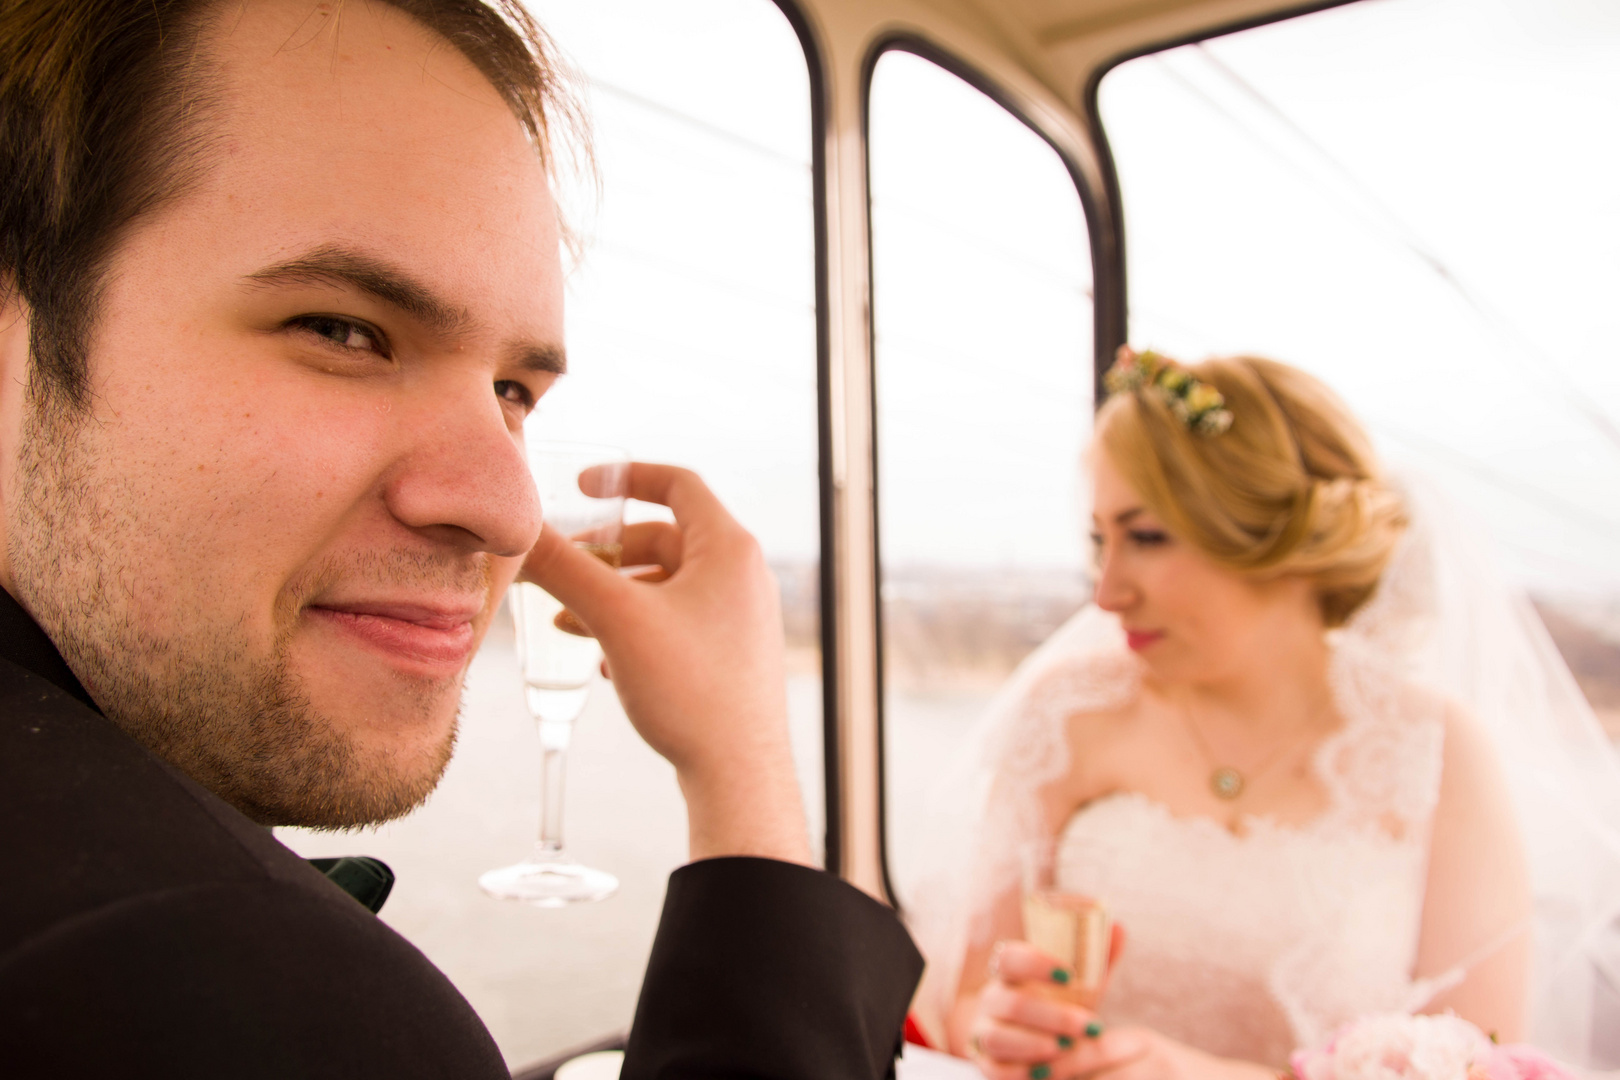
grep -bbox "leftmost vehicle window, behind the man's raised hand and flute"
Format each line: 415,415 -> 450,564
280,0 -> 823,1067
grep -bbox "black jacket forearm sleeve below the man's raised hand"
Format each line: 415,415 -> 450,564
622,858 -> 922,1080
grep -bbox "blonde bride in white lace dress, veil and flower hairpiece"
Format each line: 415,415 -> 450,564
912,350 -> 1620,1080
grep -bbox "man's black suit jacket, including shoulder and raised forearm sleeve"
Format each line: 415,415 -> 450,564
0,591 -> 922,1080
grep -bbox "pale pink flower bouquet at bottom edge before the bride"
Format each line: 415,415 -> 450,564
1291,1014 -> 1575,1080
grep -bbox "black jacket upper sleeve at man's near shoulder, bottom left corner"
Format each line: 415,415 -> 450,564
0,882 -> 510,1080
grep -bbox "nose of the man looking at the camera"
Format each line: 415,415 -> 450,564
384,382 -> 539,555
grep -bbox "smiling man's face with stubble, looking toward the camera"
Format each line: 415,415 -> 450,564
0,0 -> 562,826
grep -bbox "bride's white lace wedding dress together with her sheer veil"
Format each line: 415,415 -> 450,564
902,476 -> 1620,1069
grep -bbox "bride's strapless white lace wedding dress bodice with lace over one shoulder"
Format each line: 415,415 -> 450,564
1056,634 -> 1443,1069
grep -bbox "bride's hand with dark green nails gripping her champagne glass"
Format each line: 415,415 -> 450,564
969,941 -> 1147,1080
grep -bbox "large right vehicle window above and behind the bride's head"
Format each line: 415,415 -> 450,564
1100,0 -> 1620,733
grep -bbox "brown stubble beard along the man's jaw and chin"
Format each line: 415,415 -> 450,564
6,395 -> 462,829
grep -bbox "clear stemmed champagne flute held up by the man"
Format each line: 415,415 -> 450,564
478,442 -> 630,907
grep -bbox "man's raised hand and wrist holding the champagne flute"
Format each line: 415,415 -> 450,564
518,463 -> 810,865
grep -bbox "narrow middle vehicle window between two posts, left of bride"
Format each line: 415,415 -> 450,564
870,52 -> 1092,902
